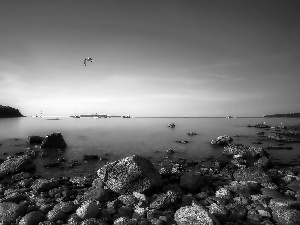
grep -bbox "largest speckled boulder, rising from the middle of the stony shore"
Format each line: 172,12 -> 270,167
97,155 -> 163,194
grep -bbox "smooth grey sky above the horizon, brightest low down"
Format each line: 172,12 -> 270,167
0,0 -> 300,117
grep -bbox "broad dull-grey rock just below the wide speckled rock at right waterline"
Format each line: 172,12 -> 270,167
233,167 -> 272,183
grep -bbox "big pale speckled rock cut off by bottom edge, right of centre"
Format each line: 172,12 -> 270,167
174,204 -> 220,225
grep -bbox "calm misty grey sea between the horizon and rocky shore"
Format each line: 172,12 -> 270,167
0,117 -> 300,176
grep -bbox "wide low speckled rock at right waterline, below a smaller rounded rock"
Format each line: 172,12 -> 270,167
223,144 -> 268,157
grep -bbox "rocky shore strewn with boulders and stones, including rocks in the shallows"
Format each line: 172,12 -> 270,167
0,125 -> 300,225
